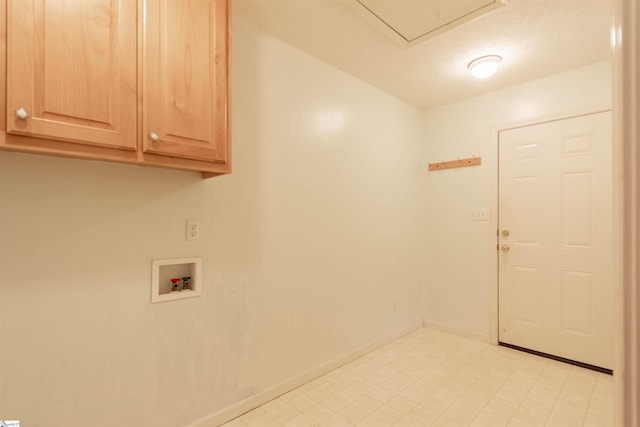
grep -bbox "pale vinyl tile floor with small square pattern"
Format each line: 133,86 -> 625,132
224,328 -> 613,427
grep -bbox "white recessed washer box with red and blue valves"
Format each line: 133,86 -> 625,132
151,257 -> 202,303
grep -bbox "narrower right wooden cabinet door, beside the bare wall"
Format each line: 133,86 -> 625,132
142,0 -> 229,164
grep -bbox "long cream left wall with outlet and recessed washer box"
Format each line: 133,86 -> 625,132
0,17 -> 423,427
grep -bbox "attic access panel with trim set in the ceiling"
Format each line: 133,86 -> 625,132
343,0 -> 508,47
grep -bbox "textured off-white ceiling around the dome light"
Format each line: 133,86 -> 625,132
232,0 -> 612,108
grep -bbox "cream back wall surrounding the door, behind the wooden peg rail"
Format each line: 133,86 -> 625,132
422,61 -> 612,338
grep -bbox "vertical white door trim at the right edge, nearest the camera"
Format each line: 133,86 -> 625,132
612,0 -> 640,426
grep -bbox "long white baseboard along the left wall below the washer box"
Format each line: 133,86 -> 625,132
186,322 -> 423,427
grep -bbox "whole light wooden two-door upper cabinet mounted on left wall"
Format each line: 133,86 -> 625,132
0,0 -> 231,177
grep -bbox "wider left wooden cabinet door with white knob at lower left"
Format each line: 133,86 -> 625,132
7,0 -> 137,150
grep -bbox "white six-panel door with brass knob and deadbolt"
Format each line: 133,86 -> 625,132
498,112 -> 614,369
